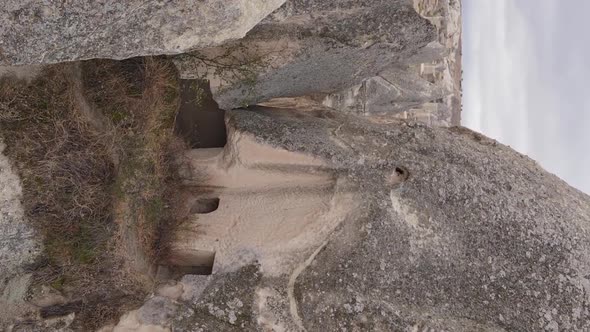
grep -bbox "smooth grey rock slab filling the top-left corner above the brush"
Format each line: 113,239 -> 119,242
0,0 -> 284,65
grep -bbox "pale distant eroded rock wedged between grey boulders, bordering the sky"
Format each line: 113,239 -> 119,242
323,0 -> 462,127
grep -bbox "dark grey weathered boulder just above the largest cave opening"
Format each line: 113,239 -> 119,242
175,0 -> 437,109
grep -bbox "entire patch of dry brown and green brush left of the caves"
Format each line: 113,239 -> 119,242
0,58 -> 184,330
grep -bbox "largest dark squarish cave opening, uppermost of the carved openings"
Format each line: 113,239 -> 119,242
175,79 -> 227,149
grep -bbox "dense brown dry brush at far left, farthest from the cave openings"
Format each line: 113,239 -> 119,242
0,65 -> 114,265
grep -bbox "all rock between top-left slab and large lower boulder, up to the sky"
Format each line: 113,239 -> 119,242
175,0 -> 461,126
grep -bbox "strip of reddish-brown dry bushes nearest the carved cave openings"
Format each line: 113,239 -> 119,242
83,58 -> 186,271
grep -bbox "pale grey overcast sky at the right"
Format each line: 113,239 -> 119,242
462,0 -> 590,194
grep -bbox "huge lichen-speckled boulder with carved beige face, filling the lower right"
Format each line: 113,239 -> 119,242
119,101 -> 590,331
